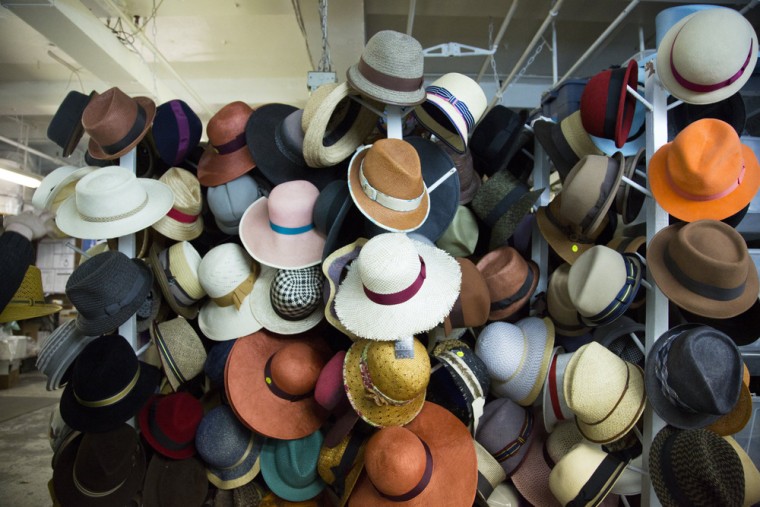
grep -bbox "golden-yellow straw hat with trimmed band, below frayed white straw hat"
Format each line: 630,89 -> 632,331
343,338 -> 430,428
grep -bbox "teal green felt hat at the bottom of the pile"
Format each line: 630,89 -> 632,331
261,430 -> 325,502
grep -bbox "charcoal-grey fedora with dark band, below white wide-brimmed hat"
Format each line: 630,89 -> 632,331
66,250 -> 153,336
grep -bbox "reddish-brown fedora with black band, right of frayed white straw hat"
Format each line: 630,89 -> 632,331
476,246 -> 539,320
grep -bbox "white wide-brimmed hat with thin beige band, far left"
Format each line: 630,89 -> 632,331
55,166 -> 174,239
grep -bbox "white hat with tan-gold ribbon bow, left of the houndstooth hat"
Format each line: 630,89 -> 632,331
198,243 -> 262,341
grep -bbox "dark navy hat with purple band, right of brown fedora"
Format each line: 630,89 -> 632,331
151,99 -> 203,166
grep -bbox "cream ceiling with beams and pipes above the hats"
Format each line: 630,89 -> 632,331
0,0 -> 760,174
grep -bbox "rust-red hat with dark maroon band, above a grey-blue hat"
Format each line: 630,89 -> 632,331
198,100 -> 256,187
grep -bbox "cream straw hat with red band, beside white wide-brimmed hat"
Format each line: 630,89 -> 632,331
152,167 -> 203,241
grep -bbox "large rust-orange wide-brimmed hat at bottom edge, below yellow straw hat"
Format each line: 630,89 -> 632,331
348,402 -> 478,506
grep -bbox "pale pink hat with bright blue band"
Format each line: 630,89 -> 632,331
239,180 -> 325,269
